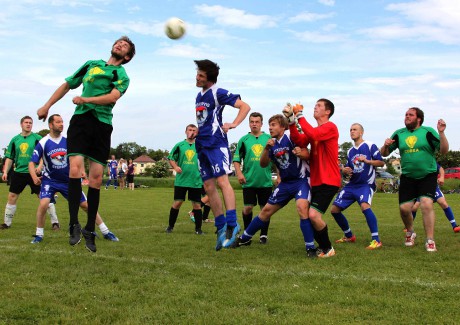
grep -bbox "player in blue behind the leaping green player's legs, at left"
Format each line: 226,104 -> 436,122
29,114 -> 118,244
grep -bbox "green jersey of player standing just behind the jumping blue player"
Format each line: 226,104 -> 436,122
168,140 -> 203,188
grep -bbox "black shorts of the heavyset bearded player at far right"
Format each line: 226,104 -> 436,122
398,173 -> 438,204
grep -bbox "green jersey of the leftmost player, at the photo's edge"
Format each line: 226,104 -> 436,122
5,133 -> 42,174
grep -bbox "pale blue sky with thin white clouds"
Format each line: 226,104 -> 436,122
0,0 -> 460,152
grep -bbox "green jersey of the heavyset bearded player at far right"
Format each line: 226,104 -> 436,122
390,126 -> 440,179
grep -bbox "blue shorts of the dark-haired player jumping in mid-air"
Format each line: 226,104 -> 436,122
198,147 -> 232,181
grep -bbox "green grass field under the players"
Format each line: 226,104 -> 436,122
0,184 -> 460,324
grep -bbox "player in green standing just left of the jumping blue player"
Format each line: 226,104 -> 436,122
166,124 -> 203,235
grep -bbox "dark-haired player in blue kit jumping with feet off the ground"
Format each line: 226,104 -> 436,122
195,60 -> 251,251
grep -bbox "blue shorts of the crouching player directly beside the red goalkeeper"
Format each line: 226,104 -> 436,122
267,179 -> 311,207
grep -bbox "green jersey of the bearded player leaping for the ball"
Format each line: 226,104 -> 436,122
65,60 -> 129,125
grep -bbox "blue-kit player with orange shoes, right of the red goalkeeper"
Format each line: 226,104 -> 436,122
331,123 -> 385,249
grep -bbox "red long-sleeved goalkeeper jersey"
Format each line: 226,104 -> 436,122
289,117 -> 342,186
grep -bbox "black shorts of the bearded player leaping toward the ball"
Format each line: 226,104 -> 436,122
67,112 -> 113,166
